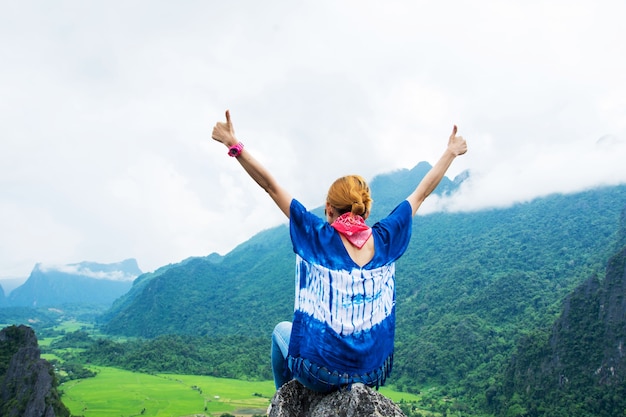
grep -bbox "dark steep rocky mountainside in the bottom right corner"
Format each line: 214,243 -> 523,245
492,242 -> 626,417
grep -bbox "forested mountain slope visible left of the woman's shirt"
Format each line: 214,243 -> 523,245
103,225 -> 293,337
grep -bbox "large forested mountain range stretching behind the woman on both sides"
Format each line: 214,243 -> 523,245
101,164 -> 626,400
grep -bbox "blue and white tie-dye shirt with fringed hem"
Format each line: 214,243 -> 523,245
289,199 -> 412,384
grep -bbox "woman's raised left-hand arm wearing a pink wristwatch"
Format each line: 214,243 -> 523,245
211,110 -> 291,217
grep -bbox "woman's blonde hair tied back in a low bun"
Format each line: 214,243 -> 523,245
326,175 -> 372,216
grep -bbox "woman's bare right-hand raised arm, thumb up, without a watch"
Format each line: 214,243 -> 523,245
407,125 -> 467,216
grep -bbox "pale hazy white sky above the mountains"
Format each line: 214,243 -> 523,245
0,0 -> 626,278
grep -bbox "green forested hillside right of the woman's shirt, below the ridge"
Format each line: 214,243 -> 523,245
388,187 -> 626,397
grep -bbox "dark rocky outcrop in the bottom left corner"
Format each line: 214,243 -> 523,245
0,326 -> 70,417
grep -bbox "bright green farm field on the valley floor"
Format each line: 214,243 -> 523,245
60,367 -> 419,417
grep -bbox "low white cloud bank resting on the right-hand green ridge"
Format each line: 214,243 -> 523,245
421,135 -> 626,214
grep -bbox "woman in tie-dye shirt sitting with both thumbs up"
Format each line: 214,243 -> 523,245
212,110 -> 467,392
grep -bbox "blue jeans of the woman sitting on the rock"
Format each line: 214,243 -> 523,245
272,321 -> 349,392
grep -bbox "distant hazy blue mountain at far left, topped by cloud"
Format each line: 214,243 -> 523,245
6,259 -> 141,307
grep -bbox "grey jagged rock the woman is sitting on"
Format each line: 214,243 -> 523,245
267,380 -> 406,417
